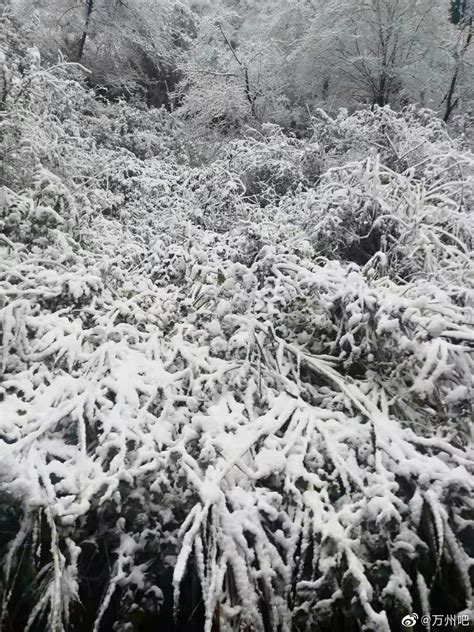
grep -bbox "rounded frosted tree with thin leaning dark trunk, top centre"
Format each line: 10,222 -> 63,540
177,8 -> 290,134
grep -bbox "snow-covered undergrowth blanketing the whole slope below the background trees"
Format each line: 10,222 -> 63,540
0,22 -> 474,632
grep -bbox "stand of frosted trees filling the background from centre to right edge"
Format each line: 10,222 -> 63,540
177,0 -> 474,131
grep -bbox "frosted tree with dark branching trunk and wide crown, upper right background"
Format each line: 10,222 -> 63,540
282,0 -> 456,107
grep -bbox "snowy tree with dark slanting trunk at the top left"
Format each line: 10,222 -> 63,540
9,0 -> 195,105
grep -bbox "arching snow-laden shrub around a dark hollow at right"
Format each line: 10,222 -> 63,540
294,158 -> 474,282
